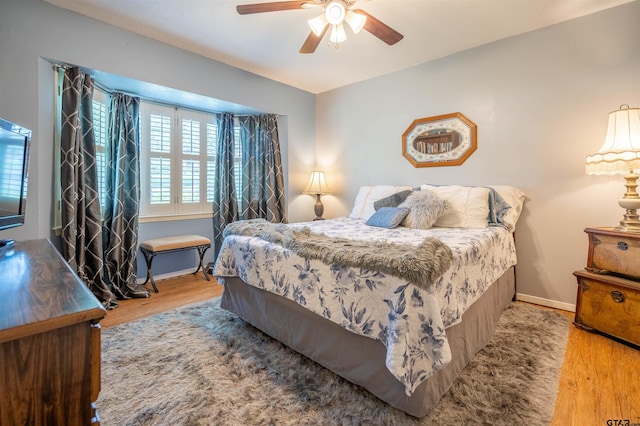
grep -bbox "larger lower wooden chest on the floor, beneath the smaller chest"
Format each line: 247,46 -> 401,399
573,271 -> 640,345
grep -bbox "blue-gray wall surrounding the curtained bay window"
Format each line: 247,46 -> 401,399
0,0 -> 315,275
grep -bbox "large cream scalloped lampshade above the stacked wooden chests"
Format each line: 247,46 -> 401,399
587,105 -> 640,175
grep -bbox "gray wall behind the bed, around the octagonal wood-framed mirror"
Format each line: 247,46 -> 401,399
316,2 -> 640,308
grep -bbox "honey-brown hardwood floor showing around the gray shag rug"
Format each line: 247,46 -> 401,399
100,274 -> 640,426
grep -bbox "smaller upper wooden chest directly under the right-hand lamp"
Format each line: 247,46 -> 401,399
585,228 -> 640,280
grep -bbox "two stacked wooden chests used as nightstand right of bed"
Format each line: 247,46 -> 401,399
574,228 -> 640,346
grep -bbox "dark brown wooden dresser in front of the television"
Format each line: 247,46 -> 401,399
0,240 -> 106,426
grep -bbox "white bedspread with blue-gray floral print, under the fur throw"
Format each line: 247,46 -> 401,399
213,218 -> 516,396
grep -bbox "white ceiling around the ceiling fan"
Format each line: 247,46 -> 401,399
45,0 -> 636,93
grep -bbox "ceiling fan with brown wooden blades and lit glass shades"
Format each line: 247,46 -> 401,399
236,0 -> 404,53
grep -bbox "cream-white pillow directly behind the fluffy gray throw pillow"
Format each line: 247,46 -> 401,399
420,185 -> 490,228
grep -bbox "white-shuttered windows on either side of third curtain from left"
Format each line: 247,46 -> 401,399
140,102 -> 241,218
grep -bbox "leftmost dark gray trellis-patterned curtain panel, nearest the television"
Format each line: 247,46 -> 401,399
60,67 -> 118,309
